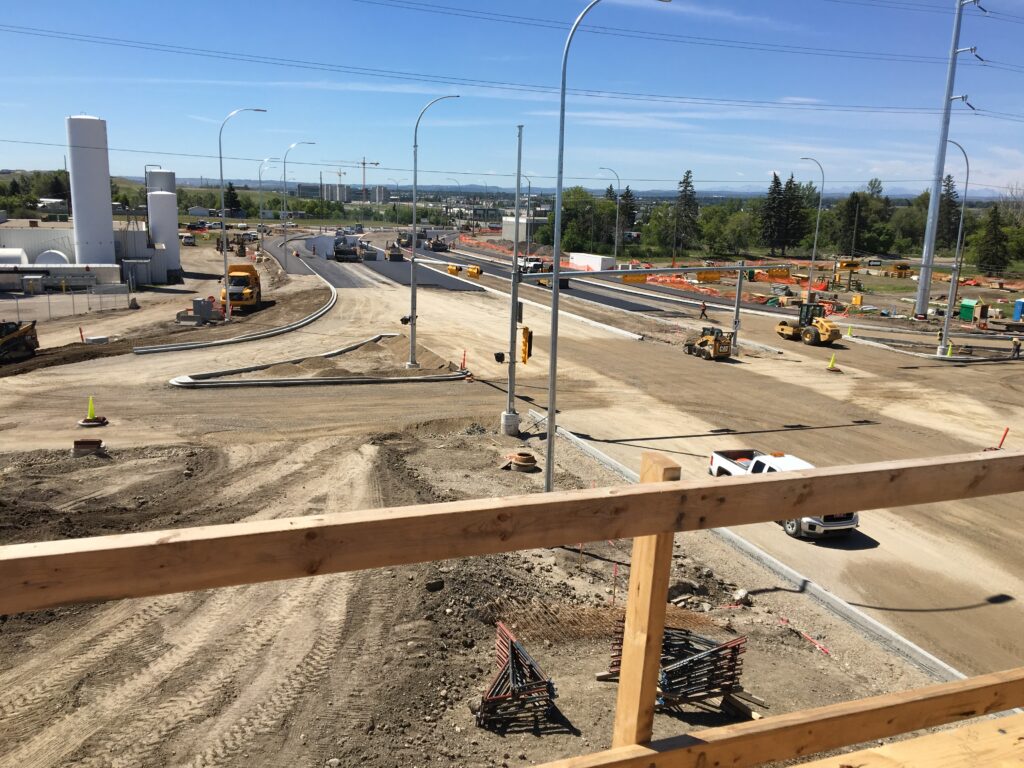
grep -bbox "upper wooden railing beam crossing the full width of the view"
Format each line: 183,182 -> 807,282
0,452 -> 1024,614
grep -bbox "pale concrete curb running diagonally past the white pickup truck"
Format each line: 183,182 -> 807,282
528,410 -> 967,682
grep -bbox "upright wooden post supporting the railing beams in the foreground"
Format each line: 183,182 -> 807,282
611,452 -> 680,748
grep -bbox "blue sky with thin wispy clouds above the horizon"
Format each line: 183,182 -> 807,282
0,0 -> 1024,190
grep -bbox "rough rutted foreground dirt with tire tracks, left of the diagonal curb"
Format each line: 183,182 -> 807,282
0,418 -> 924,768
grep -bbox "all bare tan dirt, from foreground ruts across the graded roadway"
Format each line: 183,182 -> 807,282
0,247 -> 1024,768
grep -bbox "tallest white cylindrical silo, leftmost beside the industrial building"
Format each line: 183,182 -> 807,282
68,115 -> 116,264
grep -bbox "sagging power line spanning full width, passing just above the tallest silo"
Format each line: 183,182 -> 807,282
0,25 -> 1024,120
